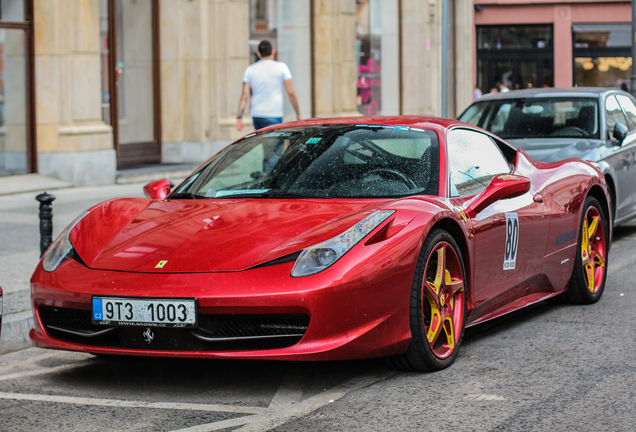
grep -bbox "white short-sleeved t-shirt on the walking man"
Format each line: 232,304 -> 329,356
243,60 -> 291,117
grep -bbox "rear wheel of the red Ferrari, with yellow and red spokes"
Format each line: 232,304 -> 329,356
565,196 -> 609,304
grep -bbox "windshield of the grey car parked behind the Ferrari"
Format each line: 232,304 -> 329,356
459,98 -> 599,139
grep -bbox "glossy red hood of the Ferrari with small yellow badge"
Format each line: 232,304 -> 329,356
70,198 -> 389,273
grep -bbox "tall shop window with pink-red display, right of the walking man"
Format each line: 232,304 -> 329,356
356,0 -> 400,115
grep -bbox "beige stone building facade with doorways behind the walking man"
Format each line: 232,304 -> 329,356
0,0 -> 474,185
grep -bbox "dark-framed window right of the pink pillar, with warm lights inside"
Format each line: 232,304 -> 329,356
572,23 -> 632,89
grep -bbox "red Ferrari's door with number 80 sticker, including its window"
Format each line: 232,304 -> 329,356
447,129 -> 550,314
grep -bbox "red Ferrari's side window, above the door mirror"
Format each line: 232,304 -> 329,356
448,129 -> 510,197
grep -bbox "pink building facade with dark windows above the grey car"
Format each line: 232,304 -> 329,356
474,0 -> 633,92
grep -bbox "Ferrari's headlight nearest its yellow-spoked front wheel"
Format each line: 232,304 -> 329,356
291,210 -> 395,277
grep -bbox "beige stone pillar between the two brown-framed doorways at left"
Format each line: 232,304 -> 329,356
34,0 -> 113,153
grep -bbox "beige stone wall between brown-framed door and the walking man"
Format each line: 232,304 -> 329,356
160,0 -> 249,148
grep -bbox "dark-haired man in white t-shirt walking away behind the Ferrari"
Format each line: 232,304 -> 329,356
236,40 -> 302,131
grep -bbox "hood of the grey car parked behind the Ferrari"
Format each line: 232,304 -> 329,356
506,138 -> 612,162
